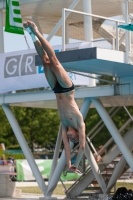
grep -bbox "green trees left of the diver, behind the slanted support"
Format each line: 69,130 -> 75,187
0,107 -> 60,151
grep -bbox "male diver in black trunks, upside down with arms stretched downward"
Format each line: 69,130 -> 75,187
23,21 -> 85,173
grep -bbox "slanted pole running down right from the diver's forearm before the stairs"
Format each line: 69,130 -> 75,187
85,142 -> 106,193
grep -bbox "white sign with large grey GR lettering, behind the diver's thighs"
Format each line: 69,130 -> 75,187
0,49 -> 90,94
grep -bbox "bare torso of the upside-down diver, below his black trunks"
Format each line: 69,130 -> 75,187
56,90 -> 83,130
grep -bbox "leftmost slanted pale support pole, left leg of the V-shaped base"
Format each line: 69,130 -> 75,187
2,104 -> 47,195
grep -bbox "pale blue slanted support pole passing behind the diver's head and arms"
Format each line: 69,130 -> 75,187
47,98 -> 91,196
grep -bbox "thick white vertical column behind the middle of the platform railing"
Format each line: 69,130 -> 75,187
83,0 -> 96,86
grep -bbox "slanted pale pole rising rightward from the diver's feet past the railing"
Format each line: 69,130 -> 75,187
47,0 -> 79,41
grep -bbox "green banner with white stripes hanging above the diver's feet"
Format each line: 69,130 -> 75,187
5,0 -> 24,35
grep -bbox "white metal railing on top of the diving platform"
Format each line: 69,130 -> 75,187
62,8 -> 130,62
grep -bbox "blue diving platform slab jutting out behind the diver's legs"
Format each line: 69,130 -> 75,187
35,47 -> 128,77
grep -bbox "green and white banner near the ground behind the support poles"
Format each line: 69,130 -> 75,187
16,159 -> 80,181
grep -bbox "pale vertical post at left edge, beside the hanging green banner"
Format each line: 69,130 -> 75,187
0,9 -> 4,53
